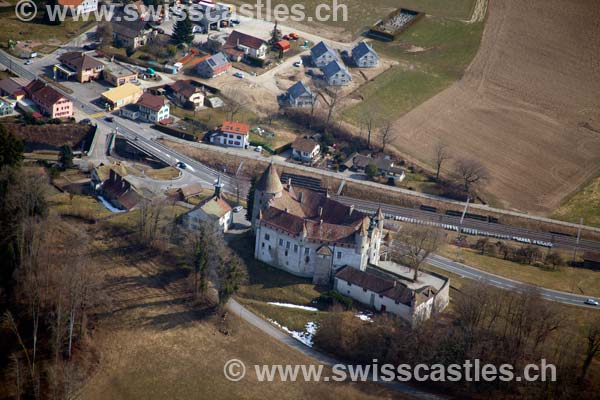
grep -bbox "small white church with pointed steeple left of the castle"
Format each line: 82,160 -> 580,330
184,177 -> 233,233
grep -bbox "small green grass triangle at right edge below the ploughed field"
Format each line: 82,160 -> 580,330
552,176 -> 600,226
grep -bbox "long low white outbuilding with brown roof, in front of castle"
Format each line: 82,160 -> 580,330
333,267 -> 450,325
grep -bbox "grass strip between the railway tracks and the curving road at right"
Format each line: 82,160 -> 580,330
439,245 -> 600,296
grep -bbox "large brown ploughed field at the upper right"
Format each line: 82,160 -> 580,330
395,0 -> 600,213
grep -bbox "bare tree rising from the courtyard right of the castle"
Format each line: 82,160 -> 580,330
394,225 -> 444,281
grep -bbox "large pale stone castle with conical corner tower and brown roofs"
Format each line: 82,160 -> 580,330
251,164 -> 383,284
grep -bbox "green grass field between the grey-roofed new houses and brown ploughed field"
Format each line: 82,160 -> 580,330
342,17 -> 483,124
